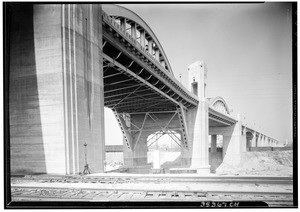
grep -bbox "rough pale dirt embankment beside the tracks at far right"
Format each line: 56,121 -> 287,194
216,151 -> 293,176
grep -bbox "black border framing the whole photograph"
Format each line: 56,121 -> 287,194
2,1 -> 298,209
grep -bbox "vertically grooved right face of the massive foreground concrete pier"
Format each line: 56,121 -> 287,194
63,4 -> 105,173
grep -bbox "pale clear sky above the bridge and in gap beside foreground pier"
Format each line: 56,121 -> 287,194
105,3 -> 292,144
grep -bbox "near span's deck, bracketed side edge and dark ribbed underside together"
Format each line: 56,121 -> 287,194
103,16 -> 198,112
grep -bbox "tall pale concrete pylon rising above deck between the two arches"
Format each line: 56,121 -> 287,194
186,61 -> 210,174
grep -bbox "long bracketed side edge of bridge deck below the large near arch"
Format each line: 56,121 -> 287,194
103,12 -> 198,104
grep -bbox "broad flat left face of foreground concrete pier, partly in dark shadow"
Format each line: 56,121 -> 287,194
9,5 -> 65,173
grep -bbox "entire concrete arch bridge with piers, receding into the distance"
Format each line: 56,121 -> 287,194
6,4 -> 278,174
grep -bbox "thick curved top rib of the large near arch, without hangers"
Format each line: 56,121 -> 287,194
102,4 -> 174,75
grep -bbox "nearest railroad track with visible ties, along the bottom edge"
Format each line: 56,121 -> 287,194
11,187 -> 293,207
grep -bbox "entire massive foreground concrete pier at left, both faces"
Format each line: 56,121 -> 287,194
8,4 -> 105,174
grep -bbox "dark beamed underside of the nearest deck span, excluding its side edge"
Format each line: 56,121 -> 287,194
103,56 -> 176,113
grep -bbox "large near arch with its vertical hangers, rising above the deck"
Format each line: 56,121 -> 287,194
102,4 -> 174,75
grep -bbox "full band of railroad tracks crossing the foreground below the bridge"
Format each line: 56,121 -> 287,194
11,175 -> 293,207
